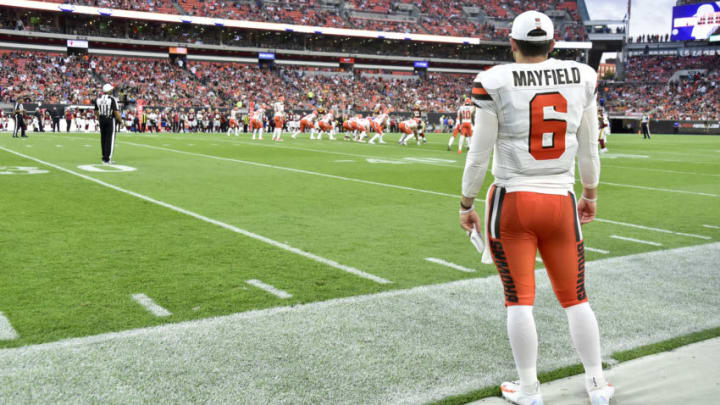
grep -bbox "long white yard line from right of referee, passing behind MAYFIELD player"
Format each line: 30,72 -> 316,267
87,142 -> 712,240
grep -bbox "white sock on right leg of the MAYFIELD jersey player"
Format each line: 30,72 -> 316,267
565,302 -> 606,386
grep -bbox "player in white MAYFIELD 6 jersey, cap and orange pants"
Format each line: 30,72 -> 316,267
460,11 -> 615,405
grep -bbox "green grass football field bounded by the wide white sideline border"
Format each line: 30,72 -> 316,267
0,133 -> 720,402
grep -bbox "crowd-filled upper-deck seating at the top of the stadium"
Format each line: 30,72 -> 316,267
25,0 -> 586,41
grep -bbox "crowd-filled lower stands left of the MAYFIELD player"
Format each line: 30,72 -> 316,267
0,52 -> 474,111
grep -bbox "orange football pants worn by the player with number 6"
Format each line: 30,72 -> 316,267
486,185 -> 587,308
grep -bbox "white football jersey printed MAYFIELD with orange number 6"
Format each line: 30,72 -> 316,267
473,59 -> 597,194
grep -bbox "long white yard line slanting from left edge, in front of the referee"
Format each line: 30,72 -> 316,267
0,146 -> 391,284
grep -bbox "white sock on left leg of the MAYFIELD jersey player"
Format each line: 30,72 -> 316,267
507,305 -> 538,393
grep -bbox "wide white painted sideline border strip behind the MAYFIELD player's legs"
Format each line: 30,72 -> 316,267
0,243 -> 720,405
